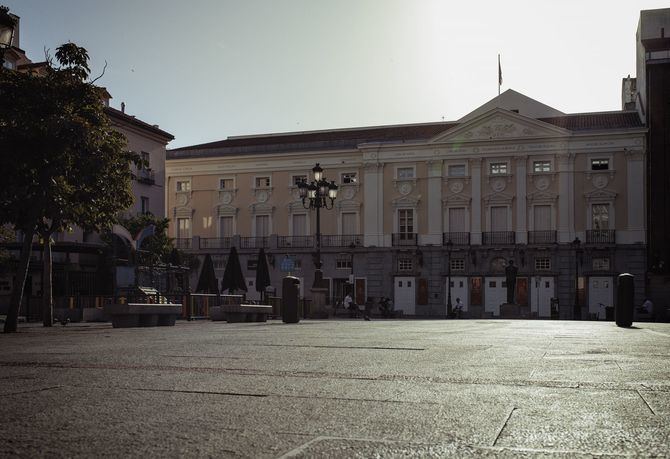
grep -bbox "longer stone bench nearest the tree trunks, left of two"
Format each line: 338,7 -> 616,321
105,303 -> 182,328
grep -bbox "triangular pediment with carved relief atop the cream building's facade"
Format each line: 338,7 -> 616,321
430,108 -> 572,143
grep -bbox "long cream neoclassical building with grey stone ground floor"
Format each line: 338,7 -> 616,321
166,90 -> 646,319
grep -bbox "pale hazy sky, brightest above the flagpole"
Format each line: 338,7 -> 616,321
5,0 -> 669,148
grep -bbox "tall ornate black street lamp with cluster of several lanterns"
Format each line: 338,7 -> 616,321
298,163 -> 337,288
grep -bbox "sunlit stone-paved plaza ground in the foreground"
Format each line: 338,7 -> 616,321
0,320 -> 670,457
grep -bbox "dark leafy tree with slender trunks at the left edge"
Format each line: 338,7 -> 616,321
0,43 -> 140,332
